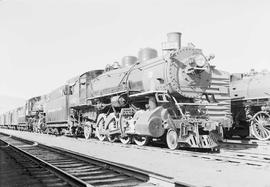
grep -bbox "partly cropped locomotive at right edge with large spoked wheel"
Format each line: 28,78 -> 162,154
228,70 -> 270,140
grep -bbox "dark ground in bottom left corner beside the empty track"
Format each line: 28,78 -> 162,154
0,141 -> 71,187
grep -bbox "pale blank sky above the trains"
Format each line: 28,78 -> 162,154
0,0 -> 270,99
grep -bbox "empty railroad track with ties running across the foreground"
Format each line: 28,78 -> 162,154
0,133 -> 191,187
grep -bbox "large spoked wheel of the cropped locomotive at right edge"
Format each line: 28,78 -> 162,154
251,111 -> 270,140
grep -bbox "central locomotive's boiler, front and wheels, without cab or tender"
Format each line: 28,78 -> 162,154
80,33 -> 228,149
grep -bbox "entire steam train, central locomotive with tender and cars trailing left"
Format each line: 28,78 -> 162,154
0,32 -> 232,149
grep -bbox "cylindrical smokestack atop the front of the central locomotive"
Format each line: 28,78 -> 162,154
162,32 -> 182,51
